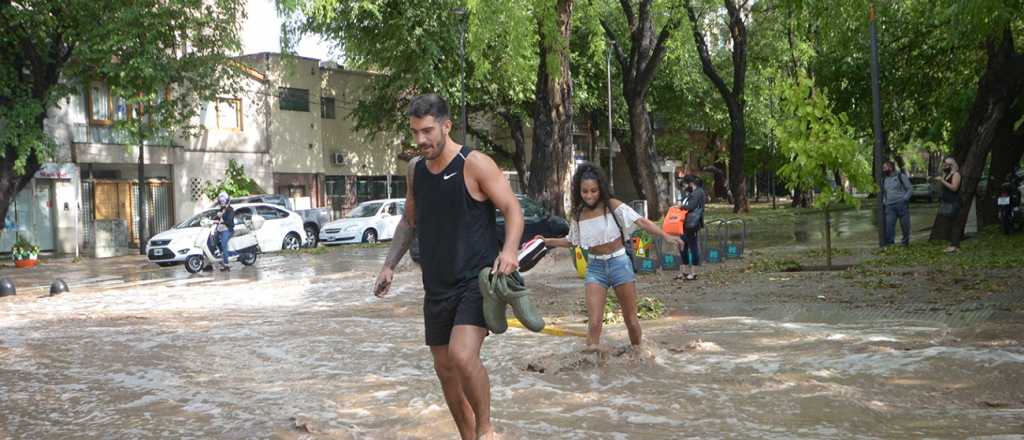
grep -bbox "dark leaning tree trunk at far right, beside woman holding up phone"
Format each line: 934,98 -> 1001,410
930,28 -> 1024,240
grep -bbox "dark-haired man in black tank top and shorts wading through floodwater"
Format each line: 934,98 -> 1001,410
374,94 -> 523,439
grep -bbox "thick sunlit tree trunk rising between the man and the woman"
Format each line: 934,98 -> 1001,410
527,0 -> 573,217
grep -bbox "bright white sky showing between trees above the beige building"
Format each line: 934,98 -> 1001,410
242,0 -> 340,60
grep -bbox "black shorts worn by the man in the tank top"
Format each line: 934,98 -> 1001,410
423,280 -> 487,346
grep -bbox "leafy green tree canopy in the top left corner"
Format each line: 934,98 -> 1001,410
0,0 -> 245,227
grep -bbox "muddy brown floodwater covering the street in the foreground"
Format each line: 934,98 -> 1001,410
0,240 -> 1024,439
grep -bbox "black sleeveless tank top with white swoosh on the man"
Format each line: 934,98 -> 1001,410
413,146 -> 498,299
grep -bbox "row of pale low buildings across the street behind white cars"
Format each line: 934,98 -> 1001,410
0,53 -> 407,257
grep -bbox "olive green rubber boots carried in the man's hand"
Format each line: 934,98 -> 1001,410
479,267 -> 544,335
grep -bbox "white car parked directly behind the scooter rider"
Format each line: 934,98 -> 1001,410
145,204 -> 306,266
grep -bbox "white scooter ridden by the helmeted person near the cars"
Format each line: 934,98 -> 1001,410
185,215 -> 264,273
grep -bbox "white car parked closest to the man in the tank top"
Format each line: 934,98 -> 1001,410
319,199 -> 406,246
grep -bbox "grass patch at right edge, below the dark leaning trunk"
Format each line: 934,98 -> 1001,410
861,227 -> 1024,270
